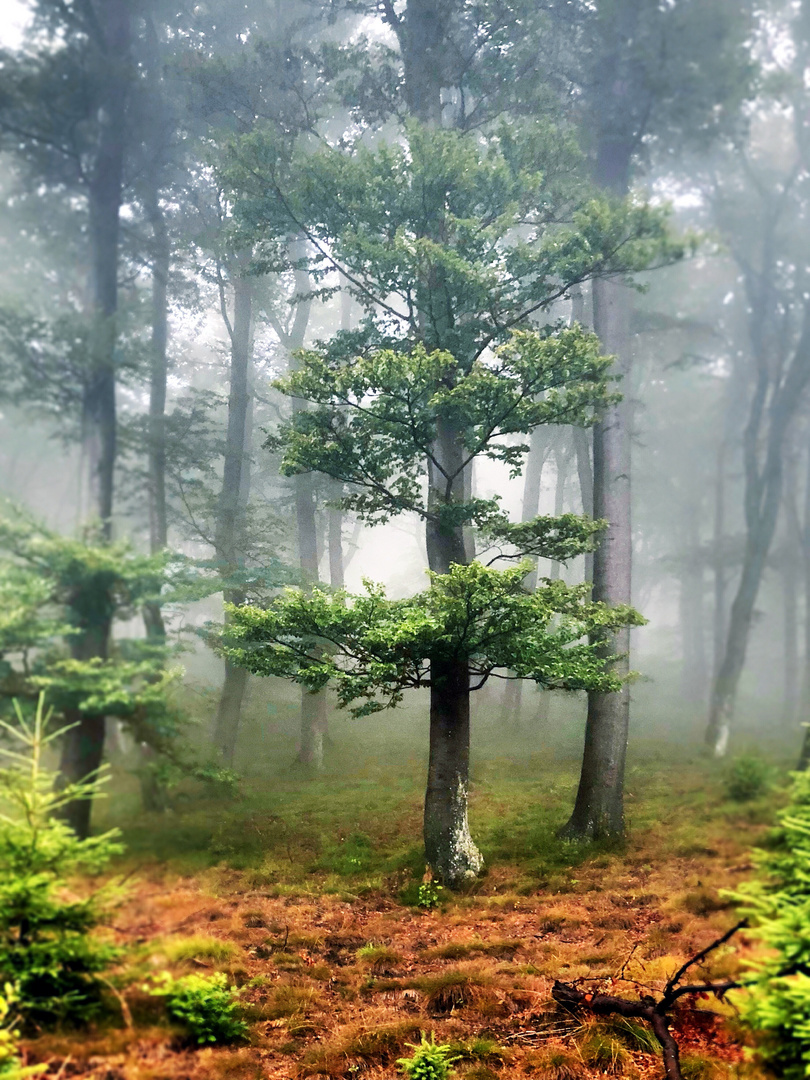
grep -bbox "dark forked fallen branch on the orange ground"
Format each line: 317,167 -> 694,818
551,919 -> 748,1080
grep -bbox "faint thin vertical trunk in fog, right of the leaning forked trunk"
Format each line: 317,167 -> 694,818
780,448 -> 802,731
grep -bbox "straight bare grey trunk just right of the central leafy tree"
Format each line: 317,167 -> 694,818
564,267 -> 633,838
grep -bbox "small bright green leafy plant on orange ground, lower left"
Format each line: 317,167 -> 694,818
146,971 -> 247,1047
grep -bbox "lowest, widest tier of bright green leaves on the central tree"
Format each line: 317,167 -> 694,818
222,563 -> 642,716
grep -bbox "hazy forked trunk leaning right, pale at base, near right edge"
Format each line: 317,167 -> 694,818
706,303 -> 810,757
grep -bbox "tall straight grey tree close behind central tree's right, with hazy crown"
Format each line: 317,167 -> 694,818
550,0 -> 750,837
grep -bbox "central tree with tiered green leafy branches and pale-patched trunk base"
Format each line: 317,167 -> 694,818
220,118 -> 683,885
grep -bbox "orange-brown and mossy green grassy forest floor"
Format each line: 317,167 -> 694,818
19,738 -> 782,1080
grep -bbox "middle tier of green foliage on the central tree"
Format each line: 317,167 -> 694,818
266,327 -> 612,529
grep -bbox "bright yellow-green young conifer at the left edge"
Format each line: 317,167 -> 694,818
0,697 -> 122,1021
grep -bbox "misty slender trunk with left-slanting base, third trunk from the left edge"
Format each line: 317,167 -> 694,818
214,274 -> 253,767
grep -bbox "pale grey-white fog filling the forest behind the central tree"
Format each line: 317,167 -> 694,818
0,0 -> 810,825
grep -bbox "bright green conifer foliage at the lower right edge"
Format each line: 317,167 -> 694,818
738,773 -> 810,1080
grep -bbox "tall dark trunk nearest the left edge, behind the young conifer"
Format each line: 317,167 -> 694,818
59,0 -> 131,837
